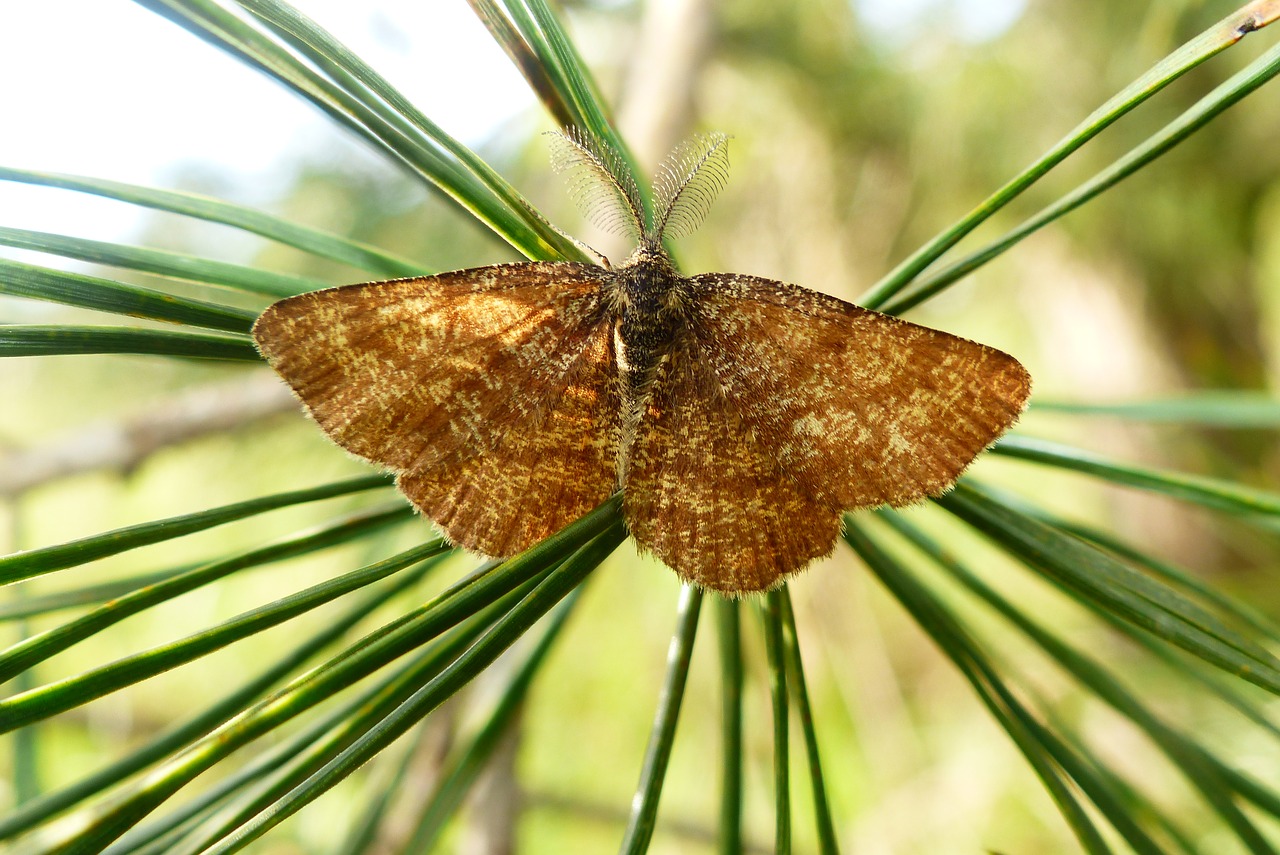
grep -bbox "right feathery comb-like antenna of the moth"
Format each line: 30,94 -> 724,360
644,133 -> 728,243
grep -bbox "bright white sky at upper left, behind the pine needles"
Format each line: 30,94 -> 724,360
0,0 -> 535,243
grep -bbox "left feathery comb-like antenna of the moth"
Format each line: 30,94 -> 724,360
547,127 -> 648,241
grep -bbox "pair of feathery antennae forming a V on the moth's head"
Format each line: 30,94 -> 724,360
548,128 -> 730,255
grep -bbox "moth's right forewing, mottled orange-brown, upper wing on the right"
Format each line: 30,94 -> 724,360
690,274 -> 1030,509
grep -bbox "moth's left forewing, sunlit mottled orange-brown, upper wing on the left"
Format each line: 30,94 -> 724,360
253,262 -> 607,470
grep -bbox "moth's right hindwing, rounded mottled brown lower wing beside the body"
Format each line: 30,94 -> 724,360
623,337 -> 840,595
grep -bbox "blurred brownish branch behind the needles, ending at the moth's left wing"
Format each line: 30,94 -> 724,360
0,372 -> 298,498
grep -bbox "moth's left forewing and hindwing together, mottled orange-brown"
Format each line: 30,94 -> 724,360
253,262 -> 620,555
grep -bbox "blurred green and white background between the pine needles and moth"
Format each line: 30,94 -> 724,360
0,0 -> 1280,854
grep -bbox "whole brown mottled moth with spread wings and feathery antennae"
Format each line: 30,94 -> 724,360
253,132 -> 1030,595
